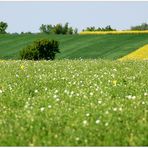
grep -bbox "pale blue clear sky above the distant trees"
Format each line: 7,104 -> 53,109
0,1 -> 148,33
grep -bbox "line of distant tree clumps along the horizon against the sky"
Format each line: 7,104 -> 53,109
0,21 -> 148,34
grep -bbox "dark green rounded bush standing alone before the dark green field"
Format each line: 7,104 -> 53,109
20,39 -> 60,60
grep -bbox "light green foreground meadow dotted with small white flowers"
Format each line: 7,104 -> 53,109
0,60 -> 148,146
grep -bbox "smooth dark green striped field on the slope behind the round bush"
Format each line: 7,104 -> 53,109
0,34 -> 148,59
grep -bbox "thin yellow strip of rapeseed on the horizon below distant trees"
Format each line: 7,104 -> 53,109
80,30 -> 148,35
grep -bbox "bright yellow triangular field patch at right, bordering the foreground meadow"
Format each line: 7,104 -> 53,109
119,44 -> 148,61
